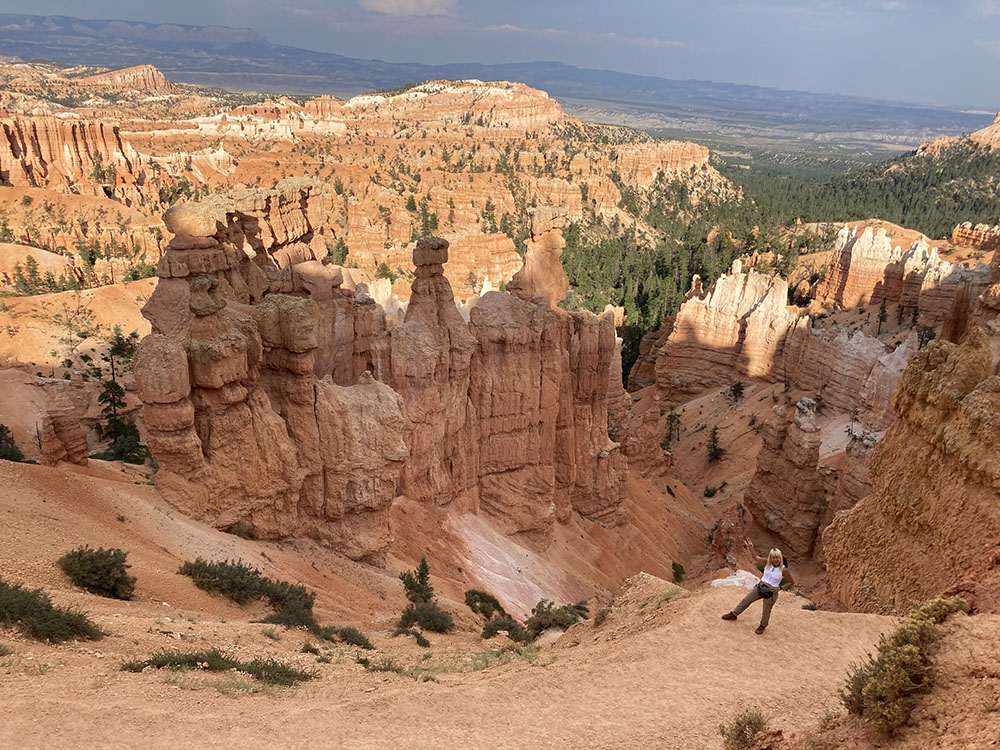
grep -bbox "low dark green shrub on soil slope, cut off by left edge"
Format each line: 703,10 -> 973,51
0,579 -> 105,643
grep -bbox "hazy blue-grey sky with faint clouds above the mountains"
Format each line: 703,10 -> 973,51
0,0 -> 1000,111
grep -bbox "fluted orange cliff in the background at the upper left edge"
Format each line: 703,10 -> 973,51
0,117 -> 143,200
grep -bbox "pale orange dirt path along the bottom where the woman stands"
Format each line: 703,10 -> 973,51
0,589 -> 889,750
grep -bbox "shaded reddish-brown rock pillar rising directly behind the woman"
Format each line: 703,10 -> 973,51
744,398 -> 826,556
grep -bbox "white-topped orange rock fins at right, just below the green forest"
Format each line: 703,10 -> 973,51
815,226 -> 989,326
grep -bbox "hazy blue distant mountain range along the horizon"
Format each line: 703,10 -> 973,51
0,13 -> 1000,146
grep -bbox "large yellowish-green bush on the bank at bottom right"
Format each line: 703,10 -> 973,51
840,597 -> 969,737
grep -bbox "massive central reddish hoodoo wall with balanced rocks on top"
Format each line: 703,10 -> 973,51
135,187 -> 627,562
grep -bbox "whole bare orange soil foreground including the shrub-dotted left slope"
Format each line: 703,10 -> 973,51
0,462 -> 892,750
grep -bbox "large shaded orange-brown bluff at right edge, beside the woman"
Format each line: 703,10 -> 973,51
823,328 -> 1000,612
